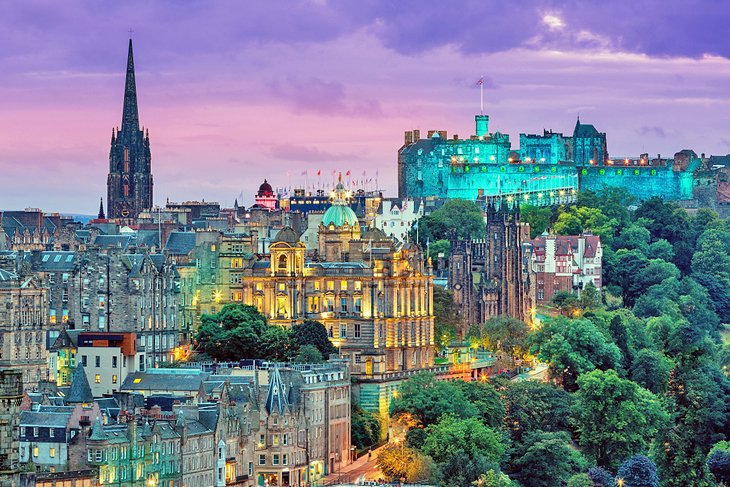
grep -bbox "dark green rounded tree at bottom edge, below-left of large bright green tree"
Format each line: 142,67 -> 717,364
509,431 -> 587,487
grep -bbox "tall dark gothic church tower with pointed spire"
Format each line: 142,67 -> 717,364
106,39 -> 152,219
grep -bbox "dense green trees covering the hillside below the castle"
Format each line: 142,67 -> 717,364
391,189 -> 730,487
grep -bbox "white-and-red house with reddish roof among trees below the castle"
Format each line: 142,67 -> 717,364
531,234 -> 603,304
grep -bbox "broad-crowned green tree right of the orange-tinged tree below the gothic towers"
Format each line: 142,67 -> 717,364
530,317 -> 621,391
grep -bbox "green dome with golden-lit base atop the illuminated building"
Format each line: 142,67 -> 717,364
319,174 -> 361,262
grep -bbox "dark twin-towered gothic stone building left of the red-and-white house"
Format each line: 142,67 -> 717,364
449,202 -> 532,336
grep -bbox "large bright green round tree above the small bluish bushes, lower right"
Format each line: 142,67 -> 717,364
573,370 -> 669,467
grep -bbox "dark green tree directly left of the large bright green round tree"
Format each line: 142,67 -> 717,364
503,381 -> 573,441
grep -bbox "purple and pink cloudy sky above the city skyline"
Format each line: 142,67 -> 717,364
0,0 -> 730,213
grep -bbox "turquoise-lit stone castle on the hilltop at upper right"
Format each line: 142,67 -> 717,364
398,115 -> 700,204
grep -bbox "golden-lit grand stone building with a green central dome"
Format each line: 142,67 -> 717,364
224,177 -> 434,412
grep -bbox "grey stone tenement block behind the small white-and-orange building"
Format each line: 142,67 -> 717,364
33,246 -> 179,366
